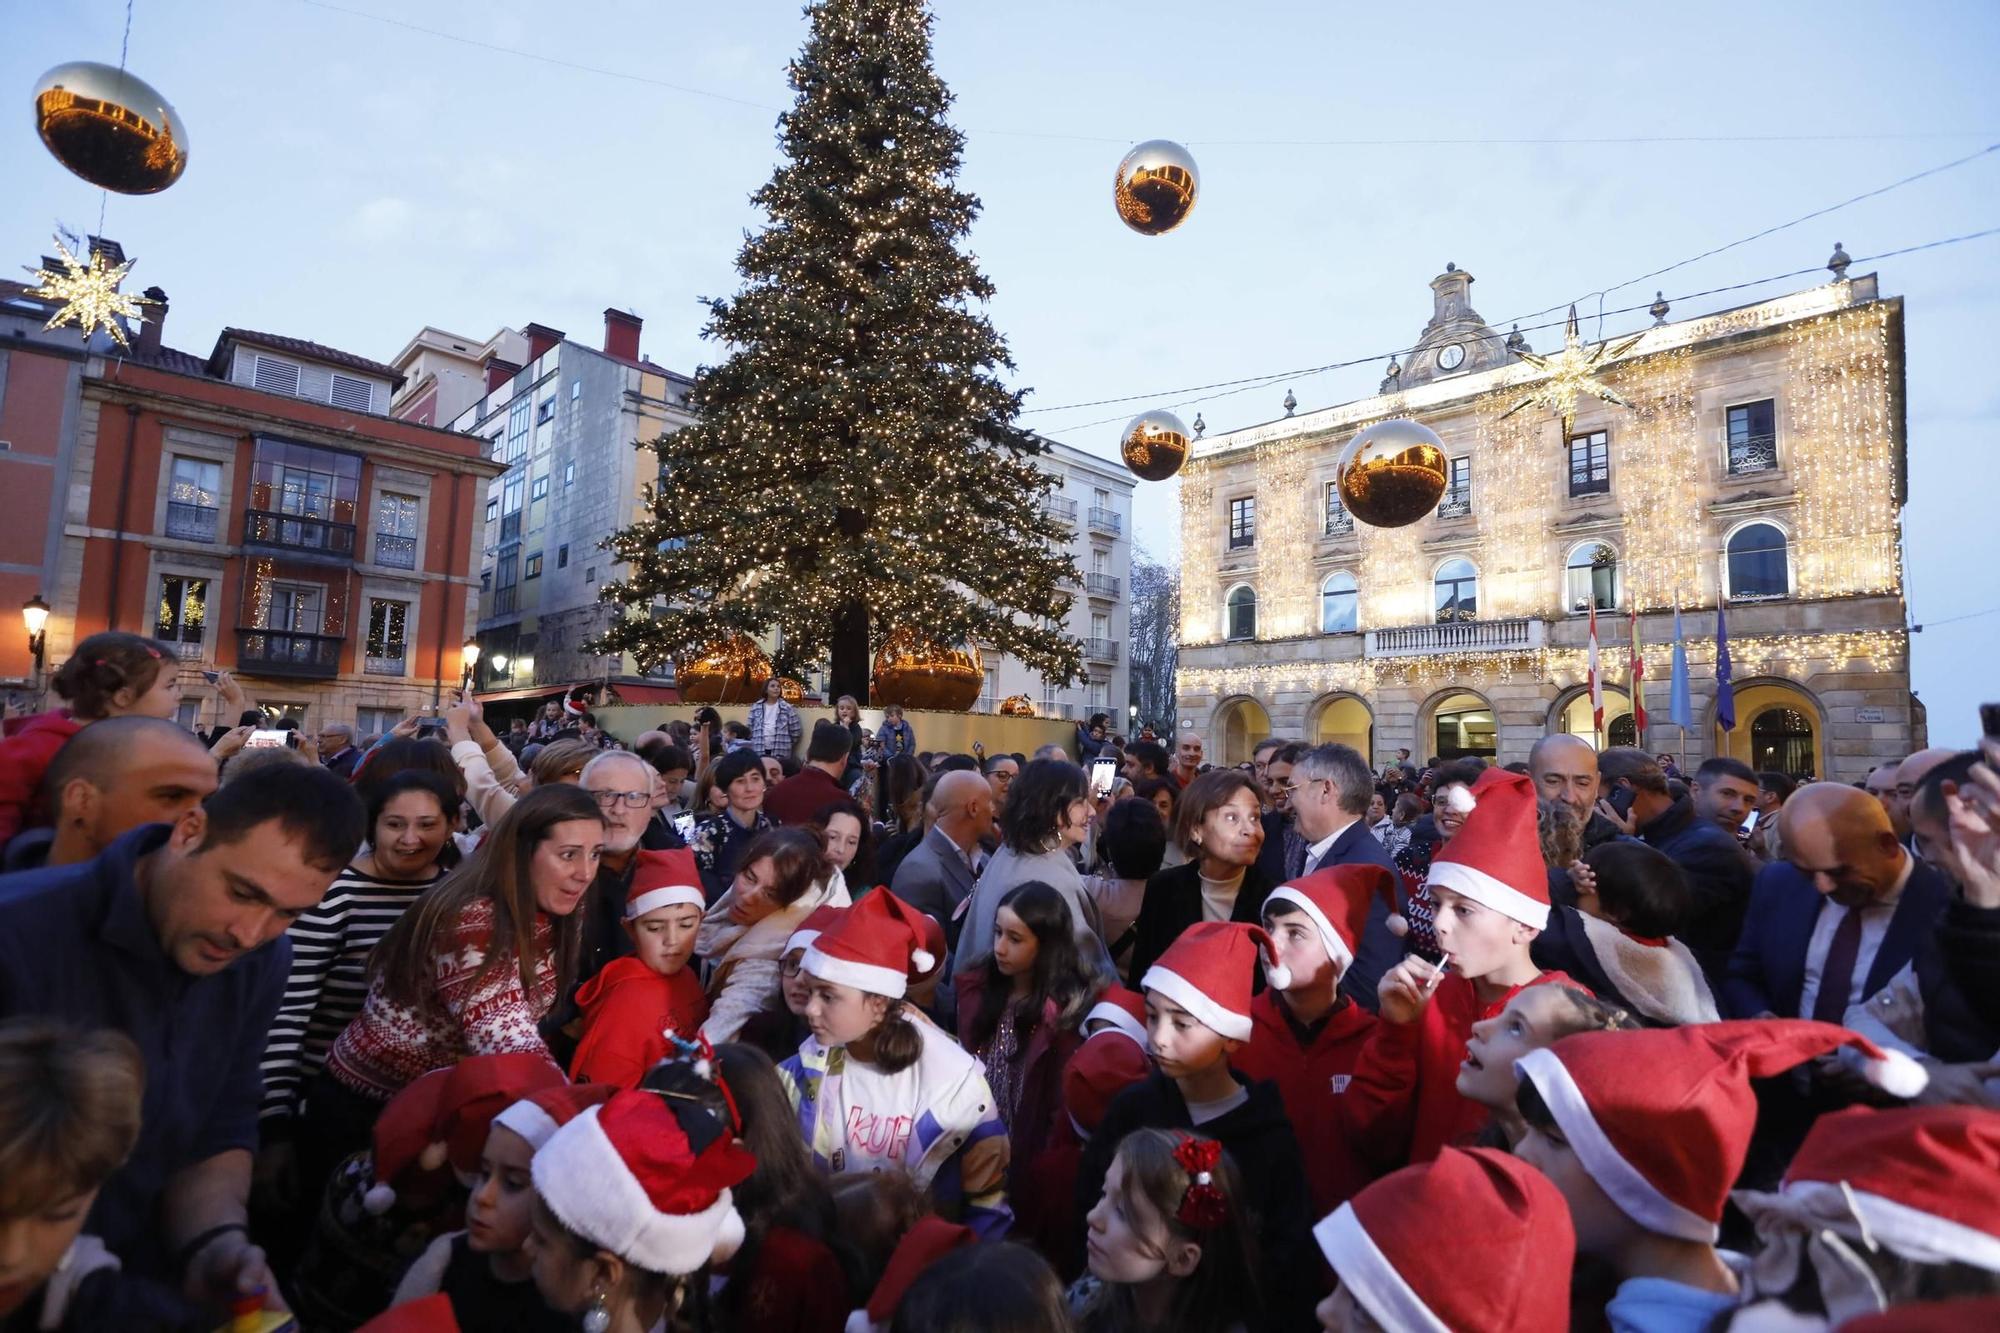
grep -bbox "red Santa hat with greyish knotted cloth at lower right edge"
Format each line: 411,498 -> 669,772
1736,1105 -> 2000,1327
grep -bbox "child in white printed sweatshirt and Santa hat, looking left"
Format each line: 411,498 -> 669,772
780,880 -> 1010,1237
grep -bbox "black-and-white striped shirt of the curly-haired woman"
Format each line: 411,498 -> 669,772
258,865 -> 444,1121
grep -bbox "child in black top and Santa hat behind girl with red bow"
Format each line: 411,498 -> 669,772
1076,921 -> 1318,1327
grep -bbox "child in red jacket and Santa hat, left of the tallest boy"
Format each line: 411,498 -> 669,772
1232,865 -> 1396,1213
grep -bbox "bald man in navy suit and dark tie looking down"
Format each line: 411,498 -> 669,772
1718,783 -> 1950,1023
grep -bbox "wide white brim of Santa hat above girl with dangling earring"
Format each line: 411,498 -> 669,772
532,1107 -> 744,1277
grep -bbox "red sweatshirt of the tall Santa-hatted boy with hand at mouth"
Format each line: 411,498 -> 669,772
1336,973 -> 1586,1175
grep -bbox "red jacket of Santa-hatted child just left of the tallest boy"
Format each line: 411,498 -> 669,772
1230,991 -> 1376,1217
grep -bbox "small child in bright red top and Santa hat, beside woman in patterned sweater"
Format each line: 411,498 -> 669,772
570,849 -> 708,1087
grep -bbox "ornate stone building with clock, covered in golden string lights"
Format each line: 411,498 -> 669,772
1178,252 -> 1924,781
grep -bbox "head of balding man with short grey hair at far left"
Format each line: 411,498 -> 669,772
20,717 -> 216,871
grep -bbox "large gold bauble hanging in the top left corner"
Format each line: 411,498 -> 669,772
34,60 -> 188,194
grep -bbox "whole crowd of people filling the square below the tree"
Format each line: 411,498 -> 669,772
0,632 -> 2000,1333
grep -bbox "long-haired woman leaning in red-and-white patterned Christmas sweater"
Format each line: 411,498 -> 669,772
302,787 -> 604,1161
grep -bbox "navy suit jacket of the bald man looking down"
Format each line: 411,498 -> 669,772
1716,861 -> 1952,1019
